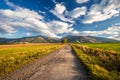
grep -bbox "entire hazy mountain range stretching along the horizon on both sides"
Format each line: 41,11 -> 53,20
0,36 -> 119,44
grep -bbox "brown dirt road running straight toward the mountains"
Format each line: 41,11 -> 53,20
0,45 -> 87,80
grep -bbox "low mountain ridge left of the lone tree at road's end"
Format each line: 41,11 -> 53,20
0,36 -> 57,43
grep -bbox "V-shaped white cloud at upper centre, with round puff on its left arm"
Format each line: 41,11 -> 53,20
50,3 -> 87,24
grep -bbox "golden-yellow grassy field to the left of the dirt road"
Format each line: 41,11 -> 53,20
0,44 -> 64,76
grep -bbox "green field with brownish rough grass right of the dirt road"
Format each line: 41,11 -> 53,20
72,43 -> 120,80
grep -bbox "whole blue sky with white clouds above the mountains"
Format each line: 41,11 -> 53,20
0,0 -> 120,40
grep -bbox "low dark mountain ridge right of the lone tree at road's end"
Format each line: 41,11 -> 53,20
65,36 -> 118,43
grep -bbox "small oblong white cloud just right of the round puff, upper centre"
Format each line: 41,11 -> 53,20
66,7 -> 87,18
